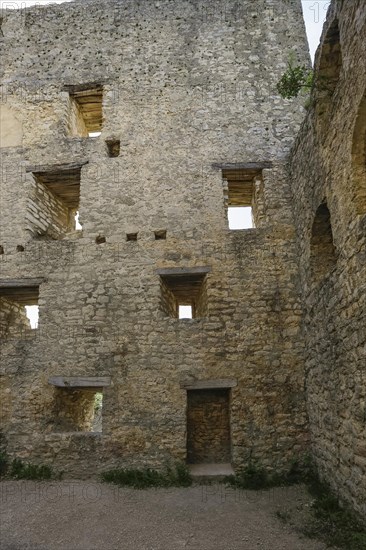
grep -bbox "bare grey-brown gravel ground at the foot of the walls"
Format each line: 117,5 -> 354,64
0,481 -> 325,550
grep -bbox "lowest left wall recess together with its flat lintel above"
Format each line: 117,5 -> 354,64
49,376 -> 111,433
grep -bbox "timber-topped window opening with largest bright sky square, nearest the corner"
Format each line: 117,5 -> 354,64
222,168 -> 263,230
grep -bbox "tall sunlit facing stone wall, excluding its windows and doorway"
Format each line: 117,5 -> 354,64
1,0 -> 309,477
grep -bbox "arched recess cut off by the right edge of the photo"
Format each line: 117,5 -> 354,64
352,91 -> 366,214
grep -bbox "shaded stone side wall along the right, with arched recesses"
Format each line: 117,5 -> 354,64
291,0 -> 366,515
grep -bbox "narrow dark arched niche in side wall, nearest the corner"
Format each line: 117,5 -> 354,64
310,203 -> 337,283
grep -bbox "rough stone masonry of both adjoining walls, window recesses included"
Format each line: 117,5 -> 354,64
0,0 -> 365,512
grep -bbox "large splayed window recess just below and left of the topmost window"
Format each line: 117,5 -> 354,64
26,163 -> 86,240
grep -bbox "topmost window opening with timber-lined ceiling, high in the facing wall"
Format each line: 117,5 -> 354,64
67,84 -> 103,138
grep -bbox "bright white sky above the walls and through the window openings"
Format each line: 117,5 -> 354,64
0,0 -> 330,327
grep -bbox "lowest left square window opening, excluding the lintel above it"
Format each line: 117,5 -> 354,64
54,387 -> 103,433
